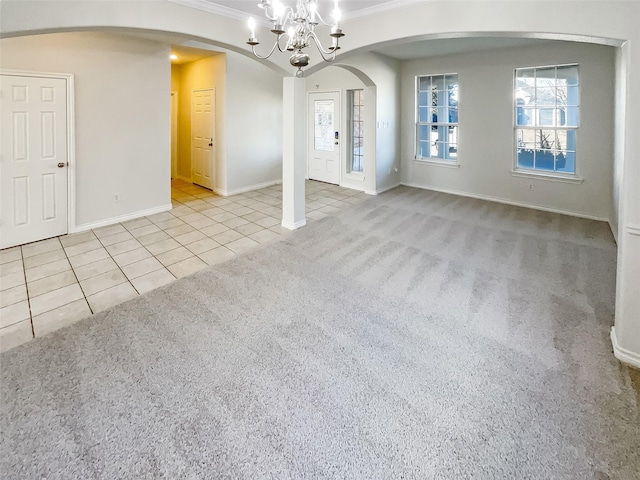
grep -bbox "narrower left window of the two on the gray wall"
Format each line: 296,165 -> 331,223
416,73 -> 458,163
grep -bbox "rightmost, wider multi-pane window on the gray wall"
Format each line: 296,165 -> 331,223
514,65 -> 580,175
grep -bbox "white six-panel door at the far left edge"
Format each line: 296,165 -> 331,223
0,74 -> 68,248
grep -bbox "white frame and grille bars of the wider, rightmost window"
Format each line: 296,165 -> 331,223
512,62 -> 582,178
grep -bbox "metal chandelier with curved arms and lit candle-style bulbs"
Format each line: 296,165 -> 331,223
247,0 -> 344,77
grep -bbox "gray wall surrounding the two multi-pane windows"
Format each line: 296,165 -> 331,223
401,42 -> 615,220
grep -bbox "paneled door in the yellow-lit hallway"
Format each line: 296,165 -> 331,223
191,89 -> 215,189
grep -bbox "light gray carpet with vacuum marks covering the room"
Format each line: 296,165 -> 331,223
0,187 -> 640,480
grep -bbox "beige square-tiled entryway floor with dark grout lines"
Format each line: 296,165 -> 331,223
0,180 -> 365,351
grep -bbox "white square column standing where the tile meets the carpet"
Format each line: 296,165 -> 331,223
282,77 -> 307,230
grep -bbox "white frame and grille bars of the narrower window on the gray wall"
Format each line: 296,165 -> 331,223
414,72 -> 460,168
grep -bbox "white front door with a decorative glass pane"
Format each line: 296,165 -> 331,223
308,92 -> 340,185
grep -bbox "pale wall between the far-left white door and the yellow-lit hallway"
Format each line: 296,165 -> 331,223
0,33 -> 171,227
